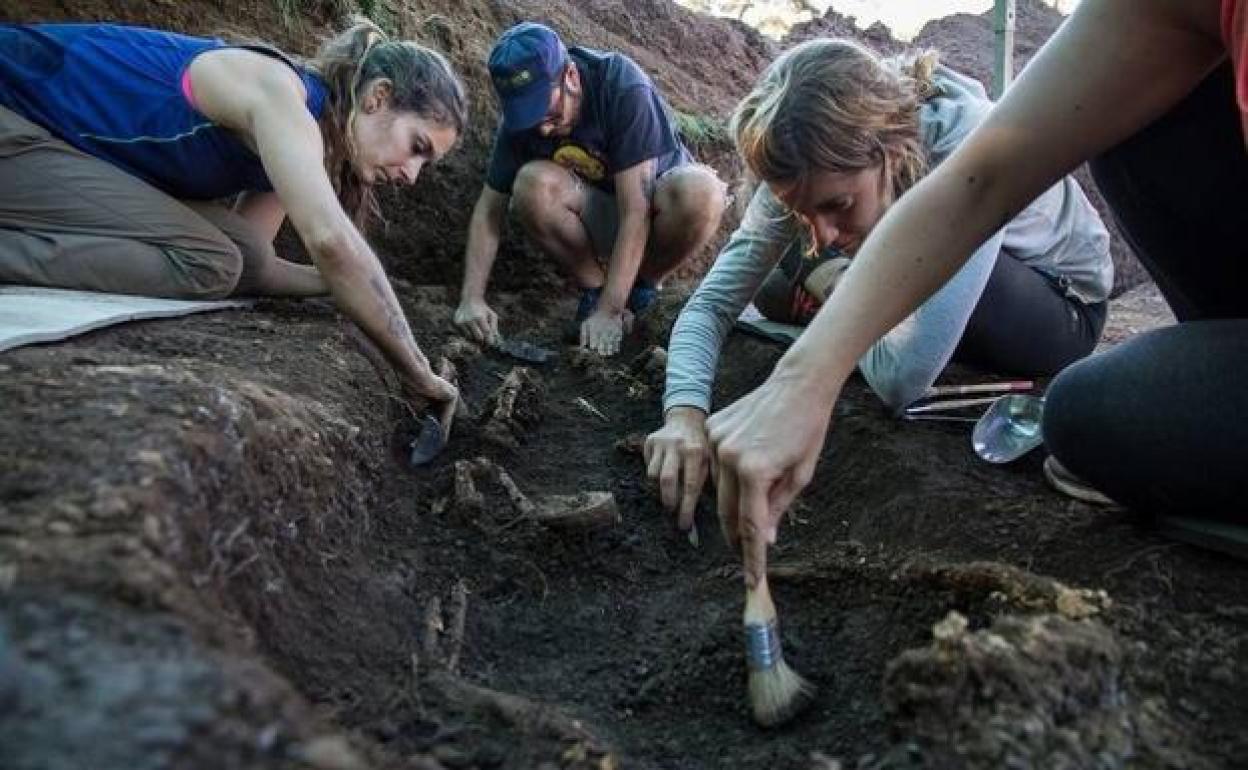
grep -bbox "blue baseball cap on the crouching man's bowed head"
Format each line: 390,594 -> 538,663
489,21 -> 568,134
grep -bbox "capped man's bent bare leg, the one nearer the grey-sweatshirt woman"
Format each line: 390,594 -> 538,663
640,165 -> 728,285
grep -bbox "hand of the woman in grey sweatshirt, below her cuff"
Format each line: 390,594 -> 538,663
644,407 -> 710,530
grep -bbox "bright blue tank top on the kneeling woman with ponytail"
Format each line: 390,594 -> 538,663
0,24 -> 327,200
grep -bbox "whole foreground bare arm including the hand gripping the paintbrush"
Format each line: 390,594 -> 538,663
706,0 -> 1224,584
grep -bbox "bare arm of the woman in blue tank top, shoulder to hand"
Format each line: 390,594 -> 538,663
192,51 -> 454,399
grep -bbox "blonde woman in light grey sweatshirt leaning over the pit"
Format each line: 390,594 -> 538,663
645,40 -> 1113,529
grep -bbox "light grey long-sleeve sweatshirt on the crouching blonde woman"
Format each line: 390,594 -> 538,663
663,67 -> 1113,412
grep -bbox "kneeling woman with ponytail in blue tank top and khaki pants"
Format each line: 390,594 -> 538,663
0,20 -> 467,401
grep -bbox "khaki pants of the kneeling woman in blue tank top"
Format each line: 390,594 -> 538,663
0,107 -> 273,300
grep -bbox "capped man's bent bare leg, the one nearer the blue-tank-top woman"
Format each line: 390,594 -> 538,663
512,161 -> 607,288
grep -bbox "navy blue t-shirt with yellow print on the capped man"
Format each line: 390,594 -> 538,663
485,47 -> 690,195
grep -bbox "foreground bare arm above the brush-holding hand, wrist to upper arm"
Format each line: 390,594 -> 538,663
781,0 -> 1223,394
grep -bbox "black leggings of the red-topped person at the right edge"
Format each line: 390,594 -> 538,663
1043,65 -> 1248,522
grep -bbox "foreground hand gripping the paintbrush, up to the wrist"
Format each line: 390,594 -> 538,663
706,369 -> 836,587
